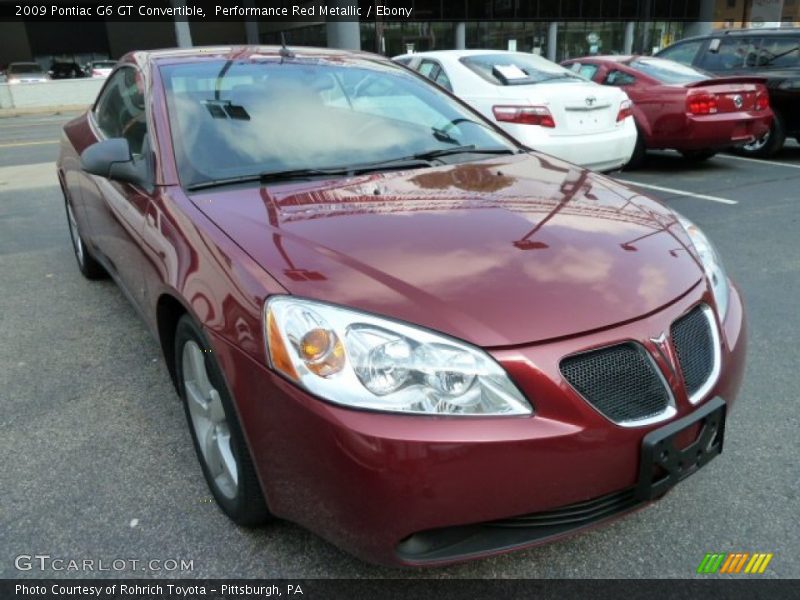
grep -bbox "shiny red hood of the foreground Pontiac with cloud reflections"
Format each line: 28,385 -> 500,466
191,154 -> 702,347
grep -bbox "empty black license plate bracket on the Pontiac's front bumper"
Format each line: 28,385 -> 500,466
636,397 -> 727,500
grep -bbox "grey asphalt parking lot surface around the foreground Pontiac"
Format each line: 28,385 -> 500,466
0,115 -> 800,578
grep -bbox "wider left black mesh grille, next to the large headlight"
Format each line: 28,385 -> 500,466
561,343 -> 669,423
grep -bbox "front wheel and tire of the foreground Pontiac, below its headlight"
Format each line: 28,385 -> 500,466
174,315 -> 270,526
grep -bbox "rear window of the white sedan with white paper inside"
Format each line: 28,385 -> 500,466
459,52 -> 584,85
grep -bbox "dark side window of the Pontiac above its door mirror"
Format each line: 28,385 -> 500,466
94,67 -> 147,154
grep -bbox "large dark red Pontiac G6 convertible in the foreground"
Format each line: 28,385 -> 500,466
57,47 -> 746,565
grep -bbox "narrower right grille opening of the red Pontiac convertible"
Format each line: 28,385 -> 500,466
670,306 -> 714,396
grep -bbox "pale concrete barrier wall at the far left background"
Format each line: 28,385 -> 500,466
0,78 -> 105,109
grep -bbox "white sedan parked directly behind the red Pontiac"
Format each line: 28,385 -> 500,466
394,50 -> 636,171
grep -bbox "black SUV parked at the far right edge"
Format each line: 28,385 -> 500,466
657,28 -> 800,157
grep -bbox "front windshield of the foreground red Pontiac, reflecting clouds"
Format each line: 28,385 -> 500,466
161,57 -> 516,187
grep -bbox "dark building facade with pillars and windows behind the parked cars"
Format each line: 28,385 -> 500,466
0,0 -> 800,68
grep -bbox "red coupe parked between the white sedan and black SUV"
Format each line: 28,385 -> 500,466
562,56 -> 773,168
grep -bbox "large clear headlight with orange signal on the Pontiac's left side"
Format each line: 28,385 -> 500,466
264,296 -> 533,416
